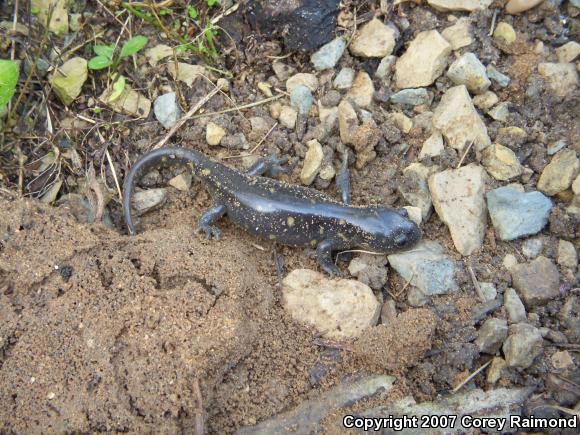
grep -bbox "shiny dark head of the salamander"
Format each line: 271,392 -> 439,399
363,207 -> 421,253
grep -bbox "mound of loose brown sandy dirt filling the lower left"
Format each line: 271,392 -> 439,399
0,201 -> 436,433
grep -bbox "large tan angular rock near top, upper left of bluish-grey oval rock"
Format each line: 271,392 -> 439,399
395,30 -> 451,89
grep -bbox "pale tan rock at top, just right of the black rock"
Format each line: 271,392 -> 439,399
349,18 -> 396,57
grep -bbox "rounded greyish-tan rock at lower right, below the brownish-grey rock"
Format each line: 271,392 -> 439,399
503,323 -> 544,369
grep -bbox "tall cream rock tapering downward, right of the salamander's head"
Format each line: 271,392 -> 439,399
429,163 -> 487,255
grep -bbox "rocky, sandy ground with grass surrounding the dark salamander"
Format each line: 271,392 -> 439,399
0,0 -> 580,433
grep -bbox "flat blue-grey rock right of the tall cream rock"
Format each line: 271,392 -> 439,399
487,186 -> 552,240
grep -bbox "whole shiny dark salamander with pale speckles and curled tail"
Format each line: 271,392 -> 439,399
123,148 -> 421,275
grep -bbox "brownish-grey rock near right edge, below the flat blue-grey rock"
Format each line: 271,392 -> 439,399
510,256 -> 560,307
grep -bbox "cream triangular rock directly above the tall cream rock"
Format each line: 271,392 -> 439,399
433,85 -> 491,151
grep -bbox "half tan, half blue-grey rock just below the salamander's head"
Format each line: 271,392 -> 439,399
388,240 -> 458,296
